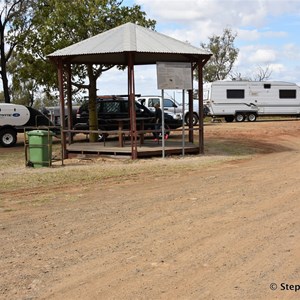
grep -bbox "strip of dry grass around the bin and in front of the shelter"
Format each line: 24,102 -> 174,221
0,141 -> 254,192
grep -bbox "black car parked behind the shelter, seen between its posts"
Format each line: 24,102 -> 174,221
74,97 -> 182,141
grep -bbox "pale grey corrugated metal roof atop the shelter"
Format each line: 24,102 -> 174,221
48,23 -> 211,64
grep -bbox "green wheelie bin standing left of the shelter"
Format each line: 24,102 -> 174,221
27,130 -> 54,168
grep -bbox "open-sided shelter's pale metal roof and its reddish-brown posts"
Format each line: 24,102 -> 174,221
48,23 -> 212,159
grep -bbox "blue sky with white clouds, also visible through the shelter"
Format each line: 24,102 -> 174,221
98,0 -> 300,98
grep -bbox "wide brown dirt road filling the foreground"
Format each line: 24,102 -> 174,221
0,121 -> 300,300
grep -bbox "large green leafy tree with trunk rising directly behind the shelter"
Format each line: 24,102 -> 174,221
13,0 -> 156,140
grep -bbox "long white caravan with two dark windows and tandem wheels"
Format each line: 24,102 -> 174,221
203,81 -> 300,122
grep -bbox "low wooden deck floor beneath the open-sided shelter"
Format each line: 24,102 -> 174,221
67,139 -> 199,158
